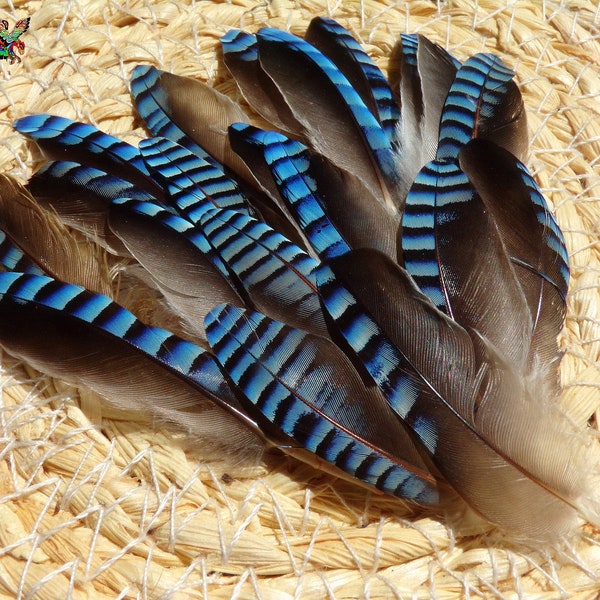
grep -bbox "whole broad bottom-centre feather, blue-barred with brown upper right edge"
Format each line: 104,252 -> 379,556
206,305 -> 438,504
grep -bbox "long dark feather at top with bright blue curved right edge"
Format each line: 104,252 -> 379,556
257,29 -> 400,210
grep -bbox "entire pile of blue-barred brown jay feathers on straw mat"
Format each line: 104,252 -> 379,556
0,18 -> 587,542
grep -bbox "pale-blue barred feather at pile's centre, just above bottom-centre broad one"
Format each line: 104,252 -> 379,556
202,209 -> 327,334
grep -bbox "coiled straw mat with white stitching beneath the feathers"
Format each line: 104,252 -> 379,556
0,0 -> 600,600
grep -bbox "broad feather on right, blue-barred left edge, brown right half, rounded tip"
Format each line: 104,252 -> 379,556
402,160 -> 532,372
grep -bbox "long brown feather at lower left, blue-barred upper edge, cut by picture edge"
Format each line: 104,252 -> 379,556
0,273 -> 262,450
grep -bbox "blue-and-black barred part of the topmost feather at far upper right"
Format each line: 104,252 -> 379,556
436,53 -> 514,159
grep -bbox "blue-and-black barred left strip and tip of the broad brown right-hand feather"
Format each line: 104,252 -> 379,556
402,160 -> 474,313
